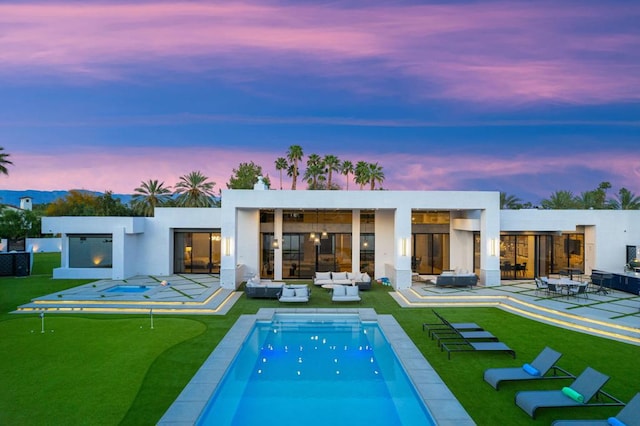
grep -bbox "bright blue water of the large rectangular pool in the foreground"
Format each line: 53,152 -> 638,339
198,314 -> 435,426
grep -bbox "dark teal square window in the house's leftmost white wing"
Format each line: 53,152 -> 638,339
69,234 -> 113,268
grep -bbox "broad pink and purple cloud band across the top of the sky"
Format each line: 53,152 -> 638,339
0,1 -> 640,106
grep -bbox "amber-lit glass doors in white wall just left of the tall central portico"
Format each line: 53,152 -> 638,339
173,231 -> 221,274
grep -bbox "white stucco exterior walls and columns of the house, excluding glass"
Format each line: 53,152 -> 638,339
42,190 -> 640,288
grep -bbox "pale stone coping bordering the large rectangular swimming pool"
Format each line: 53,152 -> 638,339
157,308 -> 475,426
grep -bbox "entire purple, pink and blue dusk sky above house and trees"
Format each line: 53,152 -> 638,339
0,0 -> 640,204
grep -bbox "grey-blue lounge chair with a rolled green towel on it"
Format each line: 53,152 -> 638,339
516,367 -> 624,418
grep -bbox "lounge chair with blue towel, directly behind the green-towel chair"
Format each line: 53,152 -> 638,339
484,347 -> 575,390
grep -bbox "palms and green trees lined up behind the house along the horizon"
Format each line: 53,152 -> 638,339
0,145 -> 640,239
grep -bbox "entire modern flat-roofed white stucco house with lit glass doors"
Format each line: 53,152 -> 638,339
42,185 -> 640,289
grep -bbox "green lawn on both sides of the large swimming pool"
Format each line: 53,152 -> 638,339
0,253 -> 640,425
